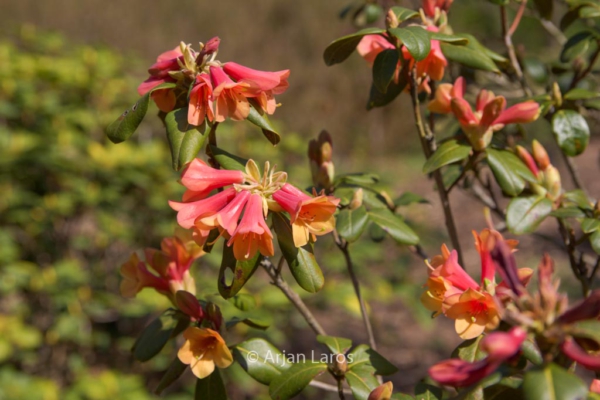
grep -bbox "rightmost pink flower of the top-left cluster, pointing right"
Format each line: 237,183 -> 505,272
223,62 -> 290,114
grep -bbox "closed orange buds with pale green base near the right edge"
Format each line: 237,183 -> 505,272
517,140 -> 562,200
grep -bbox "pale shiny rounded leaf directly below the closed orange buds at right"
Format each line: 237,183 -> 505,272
506,196 -> 552,235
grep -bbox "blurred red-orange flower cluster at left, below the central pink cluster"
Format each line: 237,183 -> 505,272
121,229 -> 204,300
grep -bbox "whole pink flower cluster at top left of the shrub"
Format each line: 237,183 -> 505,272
138,37 -> 290,125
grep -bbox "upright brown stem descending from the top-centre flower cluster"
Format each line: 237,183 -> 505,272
410,68 -> 464,265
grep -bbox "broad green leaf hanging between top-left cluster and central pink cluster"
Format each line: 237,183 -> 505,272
165,107 -> 206,171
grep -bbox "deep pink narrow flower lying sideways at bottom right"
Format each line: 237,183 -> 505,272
429,327 -> 527,387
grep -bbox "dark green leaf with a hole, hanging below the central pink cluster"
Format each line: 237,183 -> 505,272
218,241 -> 262,299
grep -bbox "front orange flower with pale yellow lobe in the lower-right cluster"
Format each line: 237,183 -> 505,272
445,288 -> 500,340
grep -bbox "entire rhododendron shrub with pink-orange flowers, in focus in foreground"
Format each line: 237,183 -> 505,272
107,0 -> 600,400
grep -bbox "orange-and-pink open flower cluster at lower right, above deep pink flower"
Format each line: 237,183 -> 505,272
421,229 -> 532,339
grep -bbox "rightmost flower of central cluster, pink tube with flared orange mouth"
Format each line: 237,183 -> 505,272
273,183 -> 340,247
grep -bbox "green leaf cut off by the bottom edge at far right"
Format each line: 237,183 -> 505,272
523,364 -> 588,400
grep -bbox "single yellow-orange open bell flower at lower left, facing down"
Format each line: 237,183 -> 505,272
177,327 -> 233,379
